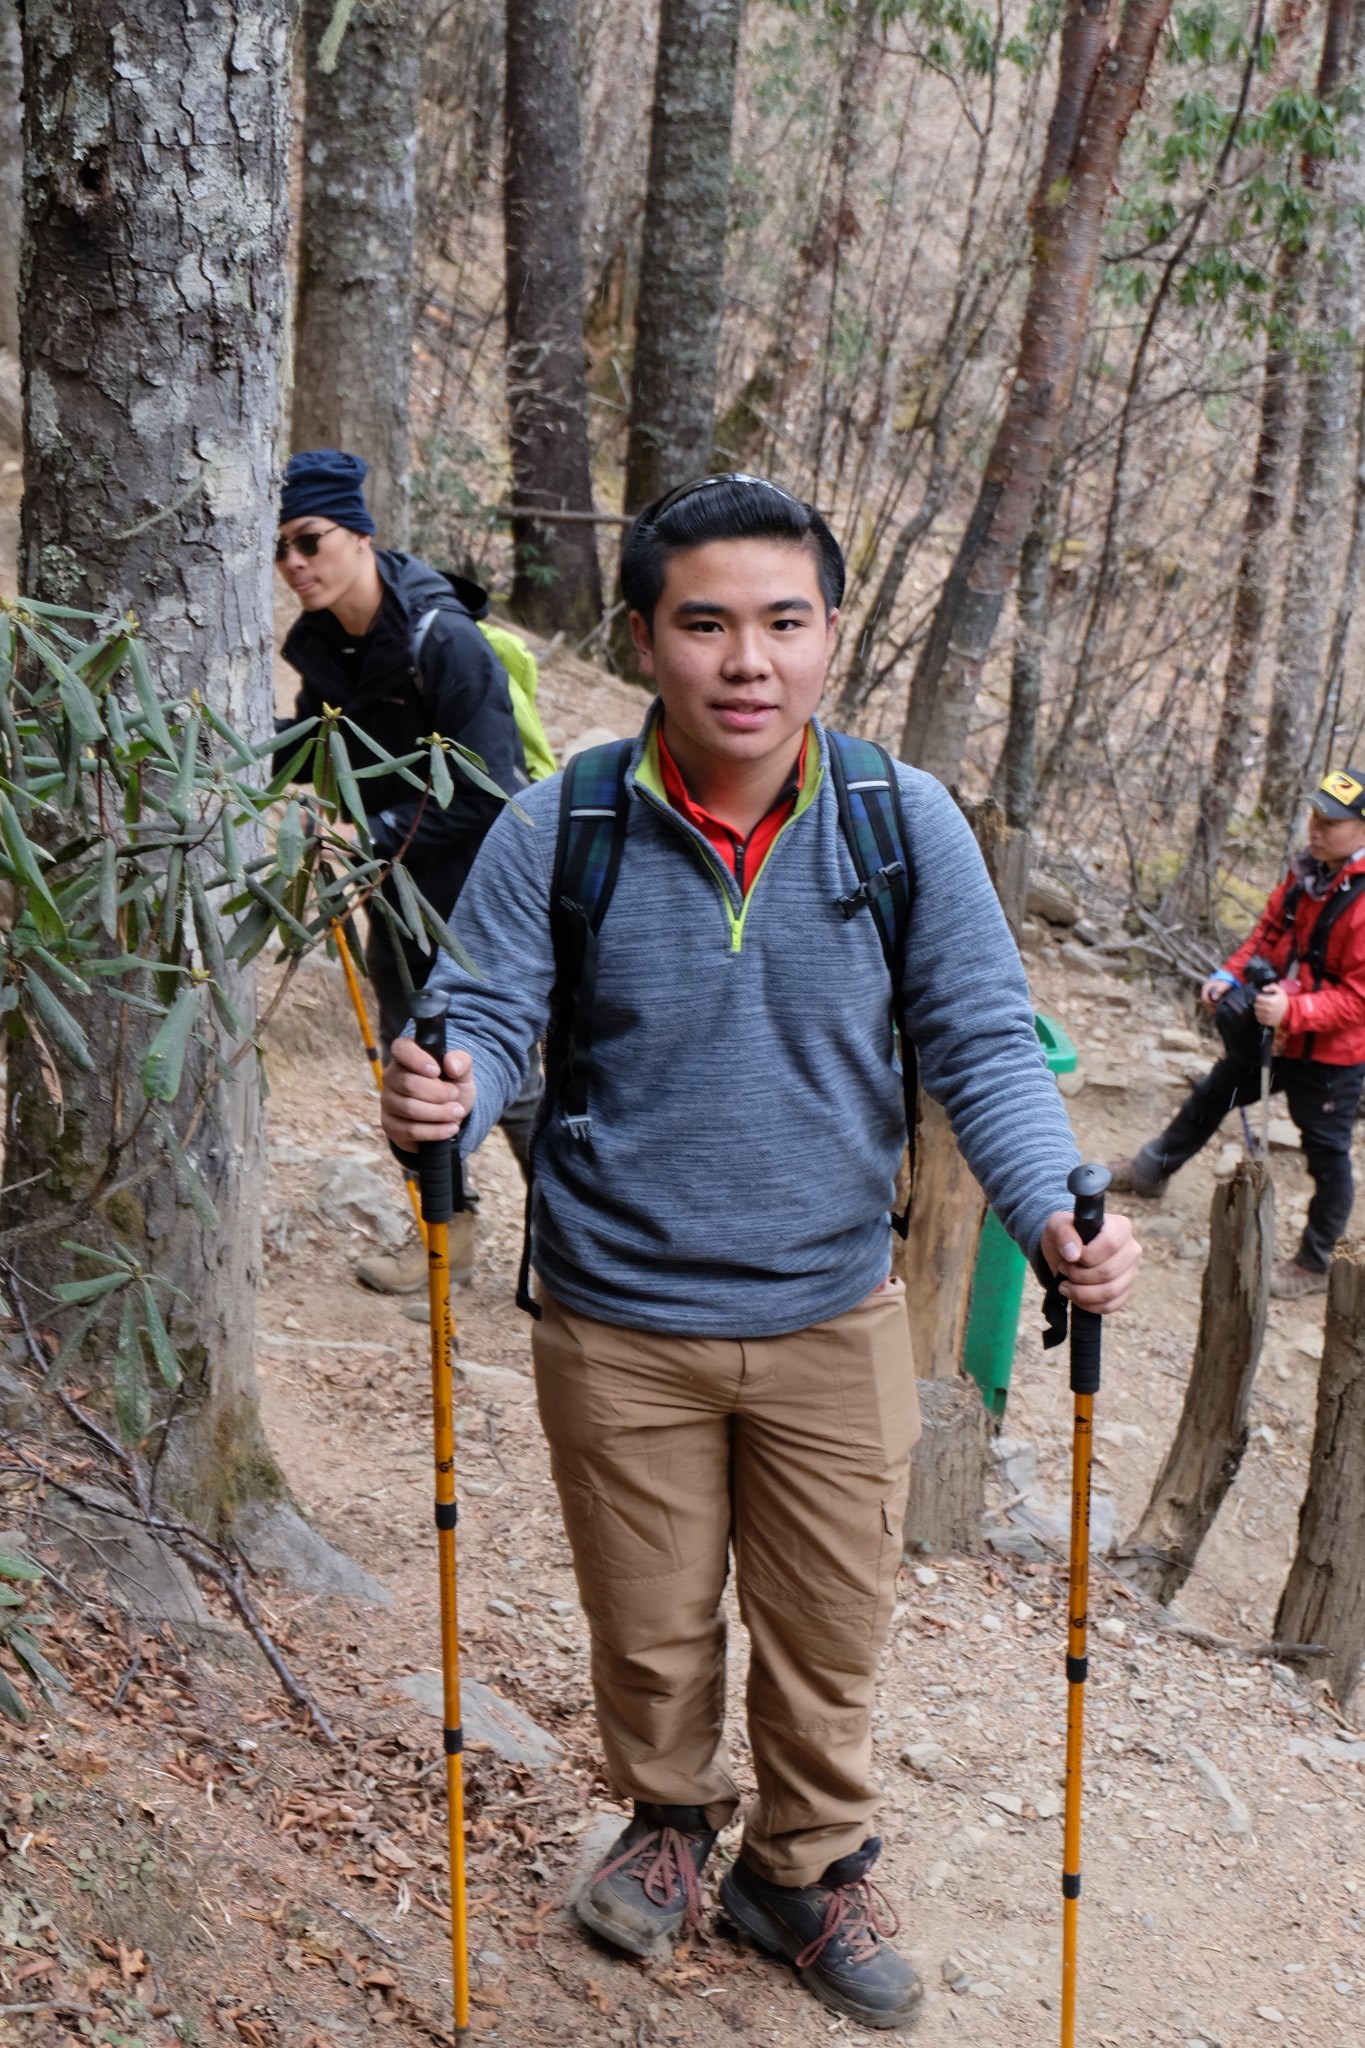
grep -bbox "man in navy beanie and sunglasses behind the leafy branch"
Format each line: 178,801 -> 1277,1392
274,449 -> 540,1294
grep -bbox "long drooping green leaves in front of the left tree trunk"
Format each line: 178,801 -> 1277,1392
0,598 -> 503,1444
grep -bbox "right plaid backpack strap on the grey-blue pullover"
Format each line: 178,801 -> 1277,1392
827,733 -> 919,1237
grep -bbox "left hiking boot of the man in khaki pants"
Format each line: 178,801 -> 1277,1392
575,1800 -> 716,1956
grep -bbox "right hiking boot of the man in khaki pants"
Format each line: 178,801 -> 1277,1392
720,1835 -> 925,2028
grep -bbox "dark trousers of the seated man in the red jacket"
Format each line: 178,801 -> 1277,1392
1136,1059 -> 1365,1272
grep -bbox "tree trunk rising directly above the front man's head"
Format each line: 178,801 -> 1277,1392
624,0 -> 739,512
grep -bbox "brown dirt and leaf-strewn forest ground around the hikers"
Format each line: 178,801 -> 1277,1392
0,630 -> 1365,2048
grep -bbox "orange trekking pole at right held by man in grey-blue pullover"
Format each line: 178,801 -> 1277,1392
1062,1165 -> 1111,2048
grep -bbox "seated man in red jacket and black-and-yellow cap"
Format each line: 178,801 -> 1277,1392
1113,768 -> 1365,1298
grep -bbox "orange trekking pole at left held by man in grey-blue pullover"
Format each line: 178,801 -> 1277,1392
411,989 -> 469,2036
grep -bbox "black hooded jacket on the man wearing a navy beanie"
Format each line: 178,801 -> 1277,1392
276,547 -> 528,915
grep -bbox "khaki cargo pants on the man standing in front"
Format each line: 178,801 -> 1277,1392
532,1282 -> 919,1884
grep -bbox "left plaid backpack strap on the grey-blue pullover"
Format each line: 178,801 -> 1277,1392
516,739 -> 634,1319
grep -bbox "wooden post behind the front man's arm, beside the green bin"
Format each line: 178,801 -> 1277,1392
892,797 -> 1029,1556
